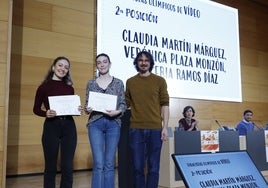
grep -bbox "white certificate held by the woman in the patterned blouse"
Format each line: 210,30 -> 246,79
88,91 -> 117,112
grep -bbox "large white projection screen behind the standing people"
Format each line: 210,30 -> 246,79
97,0 -> 242,102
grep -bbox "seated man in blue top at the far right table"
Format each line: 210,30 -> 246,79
236,110 -> 260,136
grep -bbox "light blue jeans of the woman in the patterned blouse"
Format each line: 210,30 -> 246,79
88,117 -> 120,188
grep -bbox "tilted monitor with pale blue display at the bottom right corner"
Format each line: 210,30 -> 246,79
172,151 -> 268,188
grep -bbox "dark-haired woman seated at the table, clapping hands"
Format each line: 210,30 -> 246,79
178,106 -> 199,131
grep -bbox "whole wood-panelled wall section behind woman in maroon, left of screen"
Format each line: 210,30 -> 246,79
7,0 -> 95,175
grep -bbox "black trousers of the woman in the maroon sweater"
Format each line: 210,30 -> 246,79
42,116 -> 77,188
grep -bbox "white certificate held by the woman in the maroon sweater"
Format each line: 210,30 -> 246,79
48,95 -> 81,116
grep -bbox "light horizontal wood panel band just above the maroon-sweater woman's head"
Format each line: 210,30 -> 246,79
12,26 -> 94,62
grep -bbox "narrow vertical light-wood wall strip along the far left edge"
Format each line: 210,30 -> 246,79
0,0 -> 12,187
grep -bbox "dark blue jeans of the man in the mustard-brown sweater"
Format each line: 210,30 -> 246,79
129,128 -> 162,188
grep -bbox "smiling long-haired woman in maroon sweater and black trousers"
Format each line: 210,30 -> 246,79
33,57 -> 81,188
